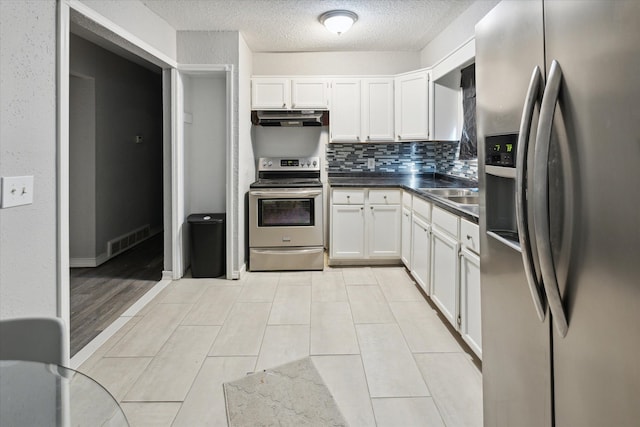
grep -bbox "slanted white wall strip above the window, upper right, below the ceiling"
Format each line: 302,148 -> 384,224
420,0 -> 500,67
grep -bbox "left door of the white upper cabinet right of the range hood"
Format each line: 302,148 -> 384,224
329,79 -> 360,142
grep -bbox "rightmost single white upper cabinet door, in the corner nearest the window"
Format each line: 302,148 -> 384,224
396,71 -> 429,140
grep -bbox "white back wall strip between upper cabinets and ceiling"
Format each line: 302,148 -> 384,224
253,52 -> 420,75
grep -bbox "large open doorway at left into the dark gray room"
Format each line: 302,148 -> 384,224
69,34 -> 164,356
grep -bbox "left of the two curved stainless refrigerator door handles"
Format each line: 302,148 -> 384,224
516,65 -> 547,321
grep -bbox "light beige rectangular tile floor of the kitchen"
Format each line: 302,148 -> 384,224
79,267 -> 482,427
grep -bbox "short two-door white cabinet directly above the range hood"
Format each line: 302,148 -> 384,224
251,77 -> 329,110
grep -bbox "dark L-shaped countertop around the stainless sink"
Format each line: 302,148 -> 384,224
329,172 -> 478,224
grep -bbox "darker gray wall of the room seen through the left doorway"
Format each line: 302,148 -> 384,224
70,35 -> 163,264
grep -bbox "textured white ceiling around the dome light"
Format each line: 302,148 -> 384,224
142,0 -> 474,52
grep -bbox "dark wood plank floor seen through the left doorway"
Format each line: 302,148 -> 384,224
70,233 -> 163,356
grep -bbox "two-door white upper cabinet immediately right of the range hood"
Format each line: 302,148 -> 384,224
330,78 -> 394,142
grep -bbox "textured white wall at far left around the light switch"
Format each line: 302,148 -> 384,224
0,0 -> 57,318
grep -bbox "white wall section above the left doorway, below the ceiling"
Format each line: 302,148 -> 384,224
80,0 -> 177,59
